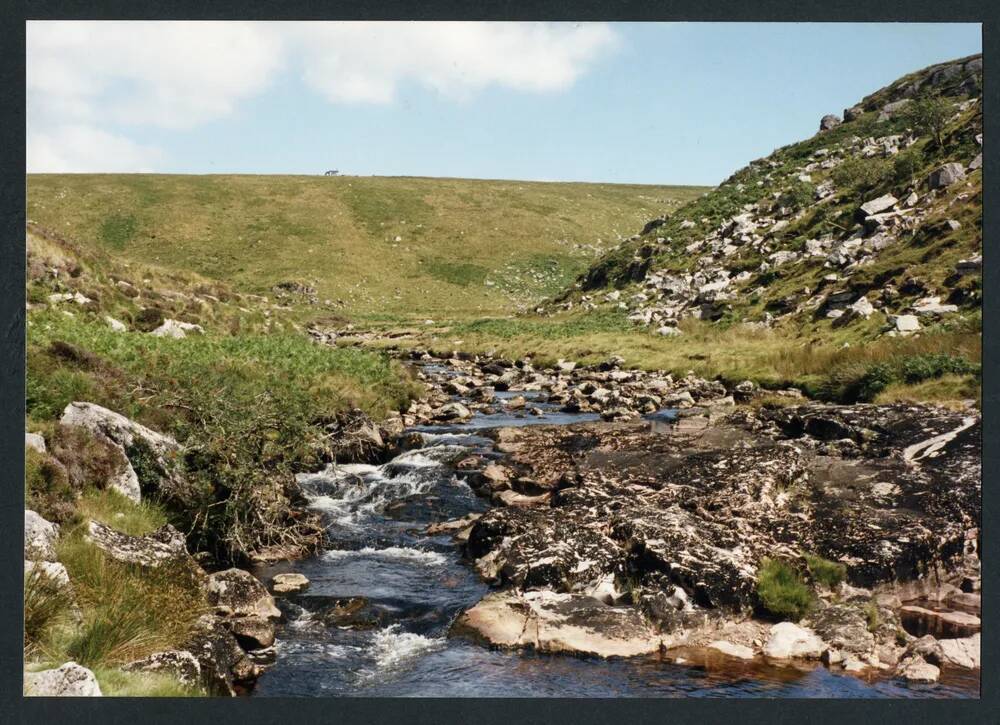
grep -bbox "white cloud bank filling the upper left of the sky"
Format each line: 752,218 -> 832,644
26,21 -> 617,171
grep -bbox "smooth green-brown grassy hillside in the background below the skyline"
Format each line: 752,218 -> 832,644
28,174 -> 705,317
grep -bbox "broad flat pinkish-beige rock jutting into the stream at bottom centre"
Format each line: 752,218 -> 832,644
451,589 -> 662,657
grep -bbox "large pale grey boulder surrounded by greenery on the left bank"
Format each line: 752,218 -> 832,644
60,402 -> 190,502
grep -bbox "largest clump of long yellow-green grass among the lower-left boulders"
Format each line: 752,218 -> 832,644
57,529 -> 207,666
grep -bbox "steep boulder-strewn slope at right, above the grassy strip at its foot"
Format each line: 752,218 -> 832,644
556,56 -> 983,338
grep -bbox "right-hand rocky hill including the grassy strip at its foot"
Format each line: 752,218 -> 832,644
384,56 -> 983,408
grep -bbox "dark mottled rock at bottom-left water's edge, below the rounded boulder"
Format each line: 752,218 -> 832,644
183,614 -> 261,696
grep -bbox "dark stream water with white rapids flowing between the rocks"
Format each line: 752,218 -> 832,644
253,368 -> 979,697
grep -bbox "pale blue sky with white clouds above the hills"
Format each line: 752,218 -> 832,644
26,21 -> 982,185
